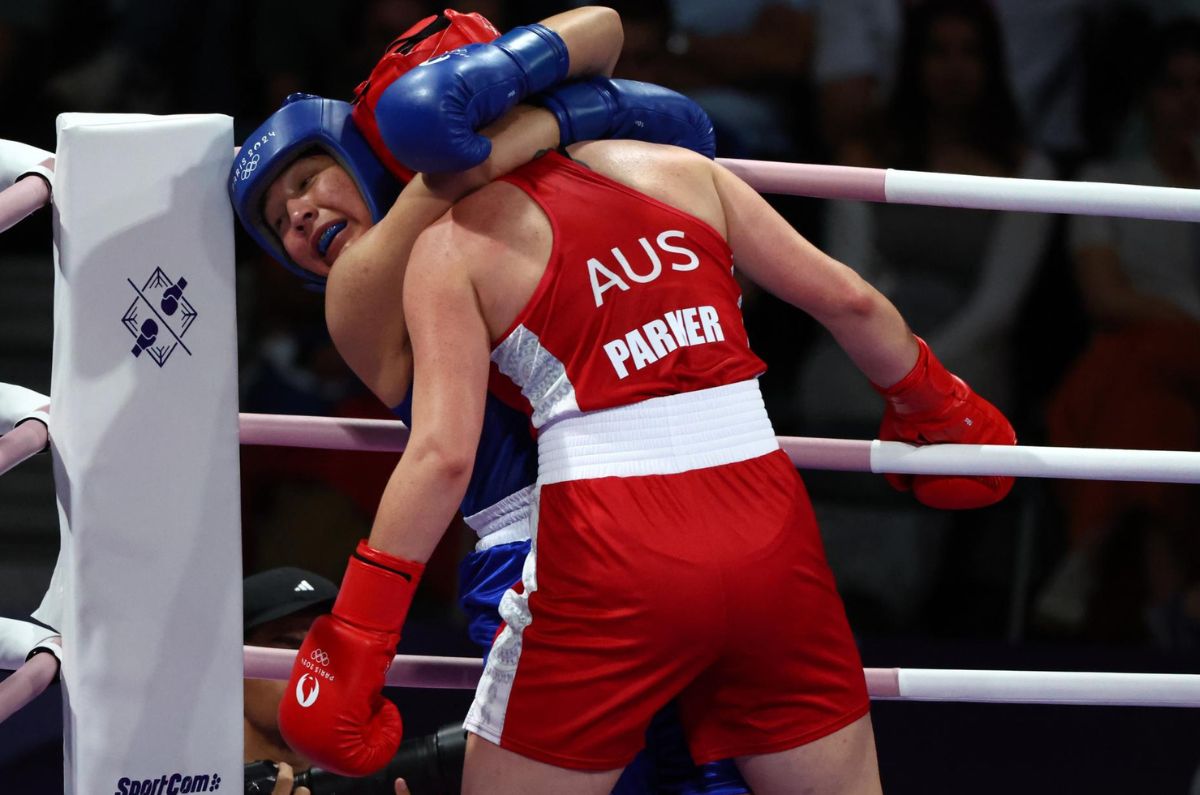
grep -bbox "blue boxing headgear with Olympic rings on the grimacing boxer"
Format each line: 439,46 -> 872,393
229,94 -> 402,289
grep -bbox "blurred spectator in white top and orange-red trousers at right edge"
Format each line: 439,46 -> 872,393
1036,19 -> 1200,647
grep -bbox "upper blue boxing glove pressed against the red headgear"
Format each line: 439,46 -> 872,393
376,25 -> 569,173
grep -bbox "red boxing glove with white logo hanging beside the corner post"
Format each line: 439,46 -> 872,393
280,540 -> 425,776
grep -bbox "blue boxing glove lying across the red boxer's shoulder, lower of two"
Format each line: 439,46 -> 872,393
533,77 -> 716,157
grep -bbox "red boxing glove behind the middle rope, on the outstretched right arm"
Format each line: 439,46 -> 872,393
875,337 -> 1016,509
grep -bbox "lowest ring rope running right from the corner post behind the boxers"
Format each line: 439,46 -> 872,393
231,646 -> 1200,707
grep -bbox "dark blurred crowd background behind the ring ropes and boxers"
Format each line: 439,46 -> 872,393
0,0 -> 1200,791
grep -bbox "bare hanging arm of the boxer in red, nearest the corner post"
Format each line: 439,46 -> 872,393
368,216 -> 494,561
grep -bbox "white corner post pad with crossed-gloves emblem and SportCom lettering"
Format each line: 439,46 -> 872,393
51,114 -> 244,795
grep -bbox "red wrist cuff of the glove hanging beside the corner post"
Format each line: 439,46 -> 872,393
334,540 -> 425,633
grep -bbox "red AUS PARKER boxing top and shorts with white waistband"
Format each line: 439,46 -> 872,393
467,154 -> 869,770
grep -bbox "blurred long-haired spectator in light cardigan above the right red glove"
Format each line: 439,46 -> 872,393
797,0 -> 1054,432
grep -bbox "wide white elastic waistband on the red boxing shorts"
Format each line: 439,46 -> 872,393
538,379 -> 779,483
